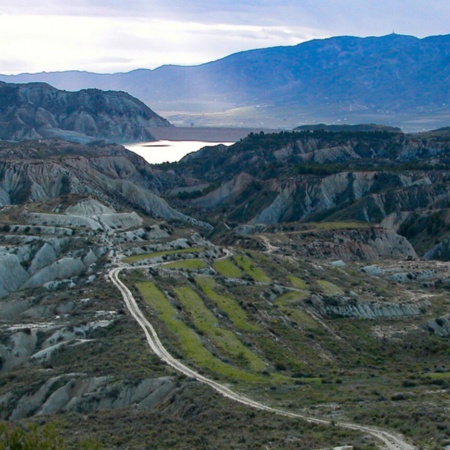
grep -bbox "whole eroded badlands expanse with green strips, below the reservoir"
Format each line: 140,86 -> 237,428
0,128 -> 450,450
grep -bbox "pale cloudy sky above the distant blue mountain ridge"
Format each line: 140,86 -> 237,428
0,0 -> 450,74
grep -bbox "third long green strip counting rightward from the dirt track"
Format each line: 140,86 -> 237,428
195,277 -> 260,331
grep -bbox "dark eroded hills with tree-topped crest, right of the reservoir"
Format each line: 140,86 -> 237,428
165,129 -> 450,254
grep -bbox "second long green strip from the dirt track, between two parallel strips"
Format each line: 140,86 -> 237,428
175,287 -> 266,371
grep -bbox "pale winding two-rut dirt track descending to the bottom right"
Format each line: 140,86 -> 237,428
108,265 -> 417,450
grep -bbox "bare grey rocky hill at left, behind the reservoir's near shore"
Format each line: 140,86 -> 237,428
0,82 -> 170,142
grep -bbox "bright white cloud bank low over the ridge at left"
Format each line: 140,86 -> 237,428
0,15 -> 326,73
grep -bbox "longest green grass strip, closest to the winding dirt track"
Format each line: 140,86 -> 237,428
136,282 -> 267,382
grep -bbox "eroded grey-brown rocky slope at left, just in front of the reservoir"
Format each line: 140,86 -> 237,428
0,140 -> 208,228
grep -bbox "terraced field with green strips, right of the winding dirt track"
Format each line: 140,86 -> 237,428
125,252 -> 450,448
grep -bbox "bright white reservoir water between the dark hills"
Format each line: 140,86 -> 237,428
125,140 -> 234,164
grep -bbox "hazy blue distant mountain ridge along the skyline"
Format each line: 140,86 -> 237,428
0,34 -> 450,128
